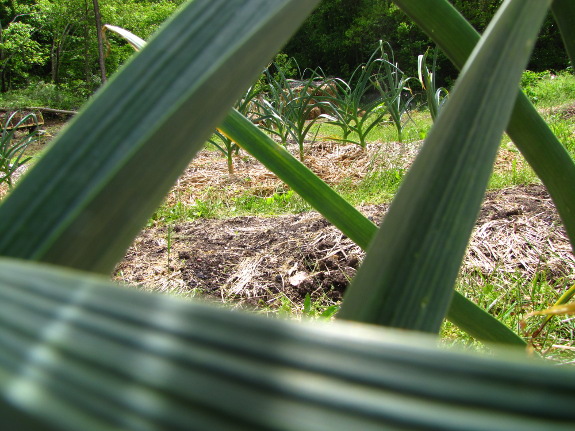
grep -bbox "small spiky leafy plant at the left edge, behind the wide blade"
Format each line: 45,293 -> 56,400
0,111 -> 38,188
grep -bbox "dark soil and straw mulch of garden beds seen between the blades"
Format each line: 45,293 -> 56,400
115,143 -> 575,308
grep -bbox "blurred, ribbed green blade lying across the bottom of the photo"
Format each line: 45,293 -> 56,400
0,259 -> 575,431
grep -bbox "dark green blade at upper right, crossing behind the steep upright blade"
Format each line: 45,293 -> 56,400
394,0 -> 575,255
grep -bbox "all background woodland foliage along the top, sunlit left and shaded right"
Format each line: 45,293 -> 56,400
0,0 -> 567,101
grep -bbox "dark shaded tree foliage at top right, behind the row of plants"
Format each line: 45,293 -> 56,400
285,0 -> 567,85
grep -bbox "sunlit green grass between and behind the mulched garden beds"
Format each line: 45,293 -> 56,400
153,90 -> 575,223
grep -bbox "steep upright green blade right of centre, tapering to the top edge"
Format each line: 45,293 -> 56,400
340,0 -> 550,332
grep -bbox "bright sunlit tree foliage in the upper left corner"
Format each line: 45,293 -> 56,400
0,0 -> 183,95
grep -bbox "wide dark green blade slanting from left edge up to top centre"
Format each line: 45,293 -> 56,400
0,0 -> 317,273
